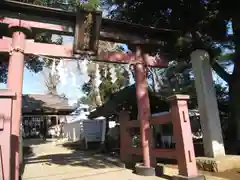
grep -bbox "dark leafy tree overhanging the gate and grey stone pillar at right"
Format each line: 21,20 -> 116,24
105,0 -> 240,143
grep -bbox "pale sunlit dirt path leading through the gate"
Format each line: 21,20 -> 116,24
23,140 -> 229,180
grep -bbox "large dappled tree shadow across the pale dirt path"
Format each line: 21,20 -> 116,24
24,143 -> 174,179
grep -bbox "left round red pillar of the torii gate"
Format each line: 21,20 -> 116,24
7,22 -> 29,180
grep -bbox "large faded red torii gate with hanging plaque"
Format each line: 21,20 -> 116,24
0,1 -> 202,180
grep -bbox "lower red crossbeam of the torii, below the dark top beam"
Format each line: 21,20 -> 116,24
0,37 -> 168,68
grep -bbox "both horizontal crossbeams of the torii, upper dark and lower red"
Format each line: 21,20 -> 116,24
0,0 -> 179,67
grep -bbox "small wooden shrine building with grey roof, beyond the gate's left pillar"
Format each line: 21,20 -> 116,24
22,94 -> 74,138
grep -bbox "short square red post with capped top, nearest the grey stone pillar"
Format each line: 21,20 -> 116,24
168,95 -> 198,179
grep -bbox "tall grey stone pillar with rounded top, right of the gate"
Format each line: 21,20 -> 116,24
191,50 -> 225,157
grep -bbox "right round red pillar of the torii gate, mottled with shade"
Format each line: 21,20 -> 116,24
134,63 -> 151,167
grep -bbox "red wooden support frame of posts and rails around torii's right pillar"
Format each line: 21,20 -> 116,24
119,95 -> 197,177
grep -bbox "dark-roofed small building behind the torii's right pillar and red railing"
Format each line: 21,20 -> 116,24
89,85 -> 202,153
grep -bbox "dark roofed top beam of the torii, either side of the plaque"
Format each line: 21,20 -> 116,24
0,0 -> 180,44
